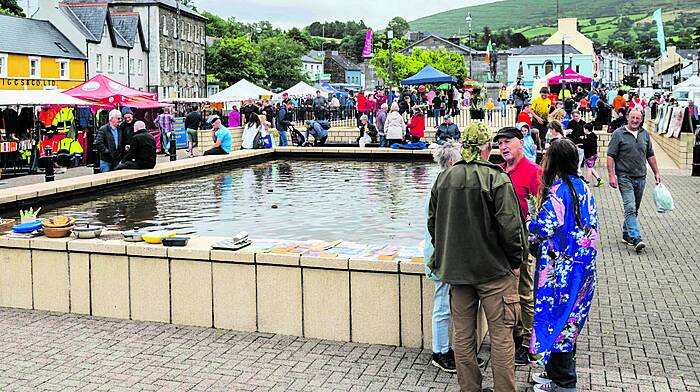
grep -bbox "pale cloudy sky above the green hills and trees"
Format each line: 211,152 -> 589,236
194,0 -> 494,30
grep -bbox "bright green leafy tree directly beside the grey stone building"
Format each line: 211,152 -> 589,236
207,37 -> 267,85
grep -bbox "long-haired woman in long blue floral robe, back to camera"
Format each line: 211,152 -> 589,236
528,139 -> 598,392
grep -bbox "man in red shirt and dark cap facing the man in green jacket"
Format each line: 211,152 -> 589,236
493,127 -> 542,366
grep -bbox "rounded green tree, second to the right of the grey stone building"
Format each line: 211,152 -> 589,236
259,35 -> 308,89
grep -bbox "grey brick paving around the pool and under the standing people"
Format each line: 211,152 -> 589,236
0,171 -> 700,391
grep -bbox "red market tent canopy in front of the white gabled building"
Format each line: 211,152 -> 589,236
64,74 -> 158,106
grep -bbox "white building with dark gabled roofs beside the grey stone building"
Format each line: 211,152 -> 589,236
31,0 -> 149,91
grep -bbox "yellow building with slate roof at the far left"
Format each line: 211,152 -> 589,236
0,15 -> 86,90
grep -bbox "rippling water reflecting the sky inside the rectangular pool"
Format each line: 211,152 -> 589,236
47,160 -> 438,245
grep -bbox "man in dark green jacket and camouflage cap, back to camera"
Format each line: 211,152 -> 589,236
428,122 -> 527,392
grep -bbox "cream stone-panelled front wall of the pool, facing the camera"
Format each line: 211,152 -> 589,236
0,234 -> 486,349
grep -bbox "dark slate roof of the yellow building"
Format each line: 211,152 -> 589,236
0,14 -> 86,60
